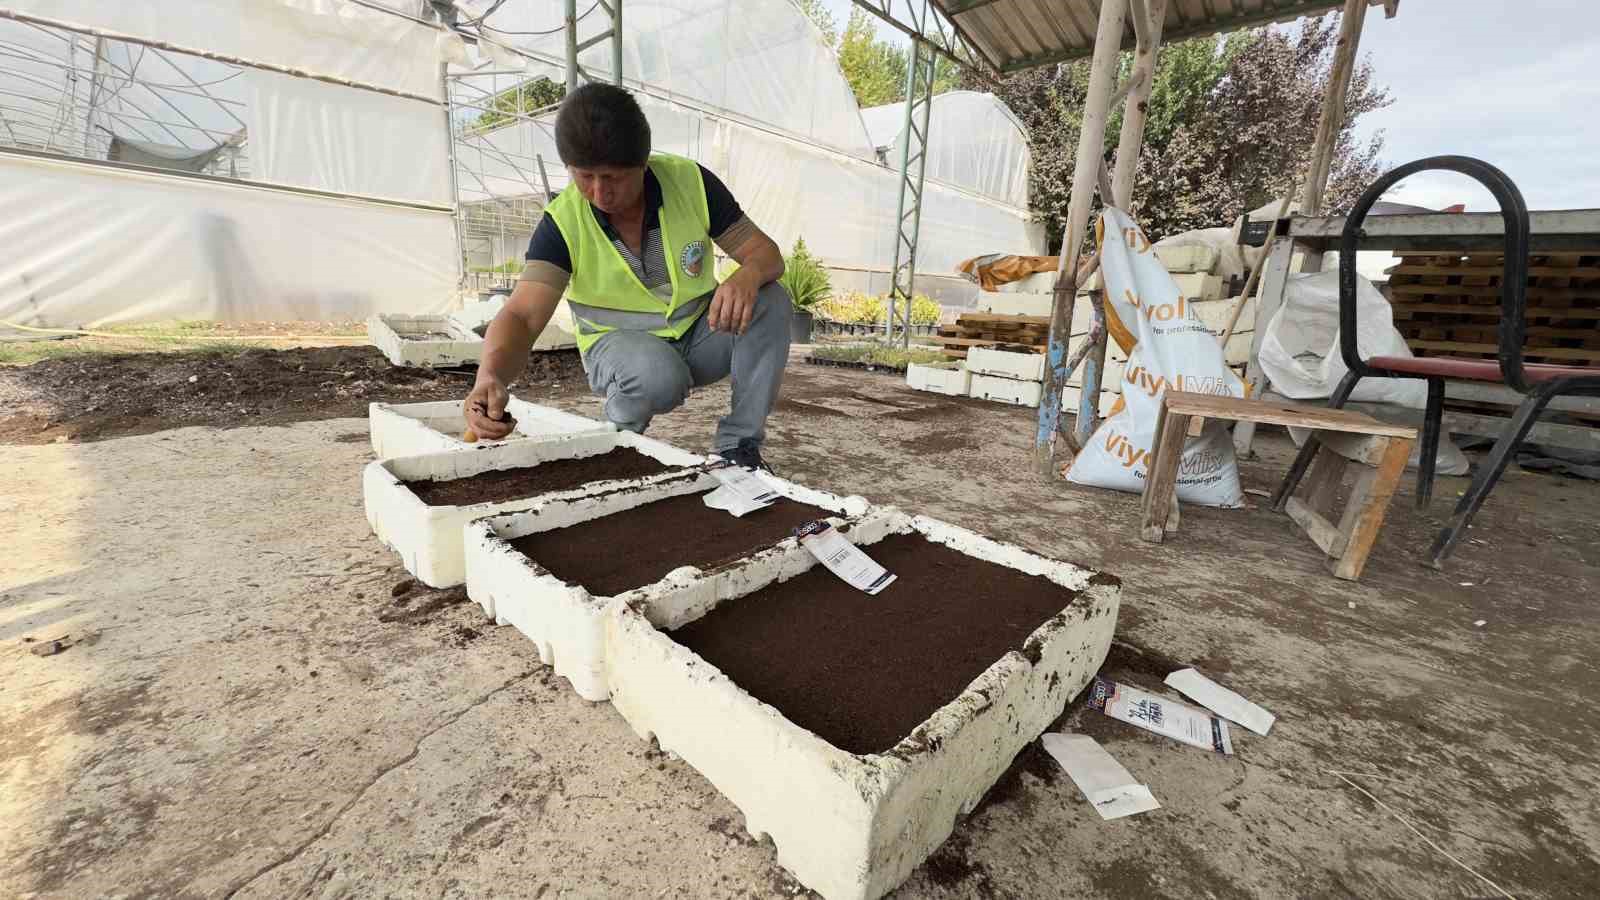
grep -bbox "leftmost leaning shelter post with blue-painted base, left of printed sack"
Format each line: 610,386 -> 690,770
1034,0 -> 1128,477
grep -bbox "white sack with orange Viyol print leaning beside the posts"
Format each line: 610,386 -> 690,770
1067,208 -> 1245,506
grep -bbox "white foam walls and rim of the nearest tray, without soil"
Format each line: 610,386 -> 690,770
606,508 -> 1122,900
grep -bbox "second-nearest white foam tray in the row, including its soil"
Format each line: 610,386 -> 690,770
464,472 -> 869,701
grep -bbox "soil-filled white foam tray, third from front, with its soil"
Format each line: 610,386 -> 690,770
371,431 -> 706,588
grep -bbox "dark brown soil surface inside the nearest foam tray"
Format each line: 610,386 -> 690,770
672,535 -> 1077,754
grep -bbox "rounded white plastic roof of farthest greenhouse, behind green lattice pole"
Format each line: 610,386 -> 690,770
861,91 -> 1030,207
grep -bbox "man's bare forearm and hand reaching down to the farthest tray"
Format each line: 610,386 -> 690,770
462,280 -> 562,440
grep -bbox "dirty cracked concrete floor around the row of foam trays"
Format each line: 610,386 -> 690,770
0,353 -> 1600,898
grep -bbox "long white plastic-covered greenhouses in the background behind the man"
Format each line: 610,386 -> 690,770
0,0 -> 1045,327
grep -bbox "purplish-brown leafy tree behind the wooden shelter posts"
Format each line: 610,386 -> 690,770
966,14 -> 1389,247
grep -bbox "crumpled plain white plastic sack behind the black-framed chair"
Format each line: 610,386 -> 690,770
1261,271 -> 1427,410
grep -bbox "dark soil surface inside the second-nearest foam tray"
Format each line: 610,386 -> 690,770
510,493 -> 832,597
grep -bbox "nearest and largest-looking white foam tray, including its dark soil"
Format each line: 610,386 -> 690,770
605,509 -> 1122,900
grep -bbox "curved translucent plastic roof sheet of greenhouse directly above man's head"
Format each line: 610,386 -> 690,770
486,0 -> 875,159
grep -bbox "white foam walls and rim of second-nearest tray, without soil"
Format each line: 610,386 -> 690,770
462,472 -> 870,701
